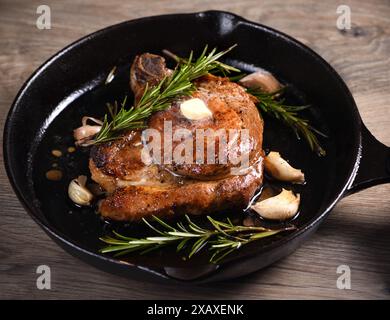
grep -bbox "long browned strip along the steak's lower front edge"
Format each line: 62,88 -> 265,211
99,160 -> 263,221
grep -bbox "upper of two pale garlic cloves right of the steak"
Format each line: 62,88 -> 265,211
264,151 -> 305,184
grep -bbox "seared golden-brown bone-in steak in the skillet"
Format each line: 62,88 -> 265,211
90,55 -> 263,221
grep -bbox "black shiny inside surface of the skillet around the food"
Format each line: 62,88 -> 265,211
6,12 -> 359,267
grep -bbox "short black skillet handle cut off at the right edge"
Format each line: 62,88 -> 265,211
346,124 -> 390,195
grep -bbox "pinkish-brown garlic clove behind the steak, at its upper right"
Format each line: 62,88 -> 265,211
239,69 -> 282,93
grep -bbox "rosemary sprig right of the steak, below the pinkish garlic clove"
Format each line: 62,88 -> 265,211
247,89 -> 326,156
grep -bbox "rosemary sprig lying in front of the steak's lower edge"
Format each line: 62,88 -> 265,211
100,215 -> 295,263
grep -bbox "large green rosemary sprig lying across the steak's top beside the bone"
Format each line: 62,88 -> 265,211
93,45 -> 235,143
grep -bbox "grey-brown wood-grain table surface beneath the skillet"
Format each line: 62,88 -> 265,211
0,0 -> 390,299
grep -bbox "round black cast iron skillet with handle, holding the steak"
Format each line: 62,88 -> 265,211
4,11 -> 390,282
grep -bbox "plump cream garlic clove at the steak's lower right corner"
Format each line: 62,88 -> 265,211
251,189 -> 301,221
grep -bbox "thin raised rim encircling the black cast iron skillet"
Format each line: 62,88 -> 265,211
3,10 -> 362,278
